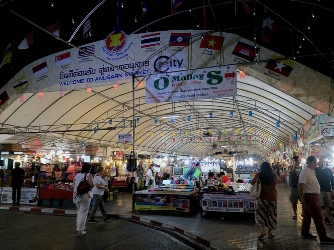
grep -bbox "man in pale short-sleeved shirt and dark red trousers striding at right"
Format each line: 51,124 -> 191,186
298,156 -> 334,244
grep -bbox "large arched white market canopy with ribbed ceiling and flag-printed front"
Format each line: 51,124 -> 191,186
1,0 -> 332,156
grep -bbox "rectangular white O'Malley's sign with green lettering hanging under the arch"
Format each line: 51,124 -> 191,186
146,66 -> 237,103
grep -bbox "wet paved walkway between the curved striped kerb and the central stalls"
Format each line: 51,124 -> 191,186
0,184 -> 334,250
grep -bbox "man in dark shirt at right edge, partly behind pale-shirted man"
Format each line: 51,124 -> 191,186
315,157 -> 334,225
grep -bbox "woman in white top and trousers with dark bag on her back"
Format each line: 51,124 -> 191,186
73,163 -> 94,237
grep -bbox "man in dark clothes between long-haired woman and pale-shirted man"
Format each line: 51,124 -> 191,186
289,156 -> 302,220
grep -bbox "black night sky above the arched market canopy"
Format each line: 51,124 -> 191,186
0,0 -> 334,86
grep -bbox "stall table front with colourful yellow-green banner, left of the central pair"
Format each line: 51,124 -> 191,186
133,188 -> 197,212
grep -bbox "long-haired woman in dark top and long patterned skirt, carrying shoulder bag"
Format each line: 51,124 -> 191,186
251,162 -> 279,239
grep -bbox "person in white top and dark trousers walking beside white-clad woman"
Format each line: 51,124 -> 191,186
88,166 -> 109,223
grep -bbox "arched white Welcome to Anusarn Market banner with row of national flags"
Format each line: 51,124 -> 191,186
0,30 -> 331,112
